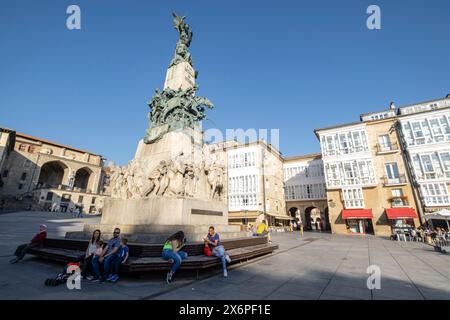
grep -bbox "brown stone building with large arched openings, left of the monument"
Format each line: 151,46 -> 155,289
0,131 -> 108,213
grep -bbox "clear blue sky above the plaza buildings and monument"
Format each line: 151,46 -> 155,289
0,0 -> 450,164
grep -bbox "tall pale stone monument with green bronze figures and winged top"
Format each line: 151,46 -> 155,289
69,13 -> 245,241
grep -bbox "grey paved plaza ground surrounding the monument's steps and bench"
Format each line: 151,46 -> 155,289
0,212 -> 450,300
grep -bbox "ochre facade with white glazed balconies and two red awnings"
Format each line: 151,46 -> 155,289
315,109 -> 420,236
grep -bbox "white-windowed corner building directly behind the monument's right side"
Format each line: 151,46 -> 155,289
210,141 -> 291,226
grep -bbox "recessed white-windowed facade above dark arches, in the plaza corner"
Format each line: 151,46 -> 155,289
283,153 -> 331,231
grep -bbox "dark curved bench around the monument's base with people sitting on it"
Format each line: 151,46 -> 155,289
29,237 -> 278,275
